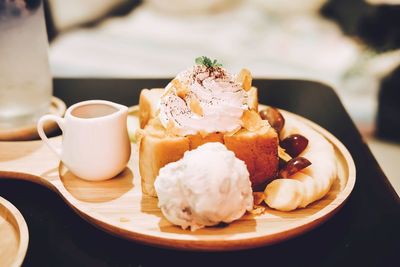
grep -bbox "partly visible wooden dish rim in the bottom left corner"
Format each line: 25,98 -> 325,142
0,197 -> 29,266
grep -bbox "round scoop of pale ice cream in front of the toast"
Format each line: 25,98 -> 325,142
154,143 -> 253,231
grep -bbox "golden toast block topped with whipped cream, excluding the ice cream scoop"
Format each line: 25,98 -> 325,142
139,59 -> 278,196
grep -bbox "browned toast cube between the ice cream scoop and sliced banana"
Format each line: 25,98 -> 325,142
224,126 -> 279,190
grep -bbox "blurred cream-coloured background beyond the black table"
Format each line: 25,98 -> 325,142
45,0 -> 400,194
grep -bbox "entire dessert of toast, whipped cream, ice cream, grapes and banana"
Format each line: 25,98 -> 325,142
137,57 -> 336,226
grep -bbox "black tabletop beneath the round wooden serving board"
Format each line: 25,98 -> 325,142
0,79 -> 400,266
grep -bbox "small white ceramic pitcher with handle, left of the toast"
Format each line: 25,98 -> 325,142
37,100 -> 131,181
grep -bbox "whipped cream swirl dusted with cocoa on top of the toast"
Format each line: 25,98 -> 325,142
159,65 -> 248,136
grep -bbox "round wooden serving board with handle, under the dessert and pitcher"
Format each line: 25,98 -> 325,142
0,106 -> 356,251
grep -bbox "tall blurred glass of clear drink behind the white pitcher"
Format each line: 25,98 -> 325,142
0,0 -> 52,130
